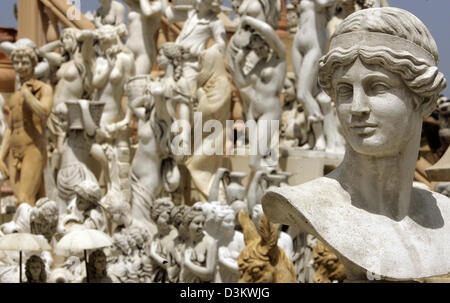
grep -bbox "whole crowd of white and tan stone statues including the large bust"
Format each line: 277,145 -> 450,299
0,0 -> 450,283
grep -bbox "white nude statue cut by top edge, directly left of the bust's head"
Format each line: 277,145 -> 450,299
292,0 -> 343,153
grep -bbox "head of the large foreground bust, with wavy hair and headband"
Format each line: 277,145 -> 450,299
319,7 -> 446,156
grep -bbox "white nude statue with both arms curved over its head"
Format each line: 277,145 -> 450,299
227,16 -> 286,170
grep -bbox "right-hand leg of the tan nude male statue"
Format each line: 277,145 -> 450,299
17,145 -> 46,206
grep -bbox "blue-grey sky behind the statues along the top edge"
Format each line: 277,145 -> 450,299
0,0 -> 450,97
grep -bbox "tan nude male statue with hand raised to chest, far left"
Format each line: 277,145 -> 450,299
0,47 -> 53,205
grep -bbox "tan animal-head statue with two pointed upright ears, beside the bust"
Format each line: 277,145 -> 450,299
238,211 -> 297,283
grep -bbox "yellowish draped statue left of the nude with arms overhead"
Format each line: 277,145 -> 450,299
185,44 -> 232,201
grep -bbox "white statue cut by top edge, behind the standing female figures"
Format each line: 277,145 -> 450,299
93,0 -> 127,28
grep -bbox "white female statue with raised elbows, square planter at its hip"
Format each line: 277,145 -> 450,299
39,28 -> 102,214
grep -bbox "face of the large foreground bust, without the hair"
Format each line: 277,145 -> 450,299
332,58 -> 423,156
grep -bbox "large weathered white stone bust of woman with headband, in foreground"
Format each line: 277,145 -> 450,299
262,8 -> 450,281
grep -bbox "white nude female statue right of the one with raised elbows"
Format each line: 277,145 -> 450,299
91,25 -> 134,201
